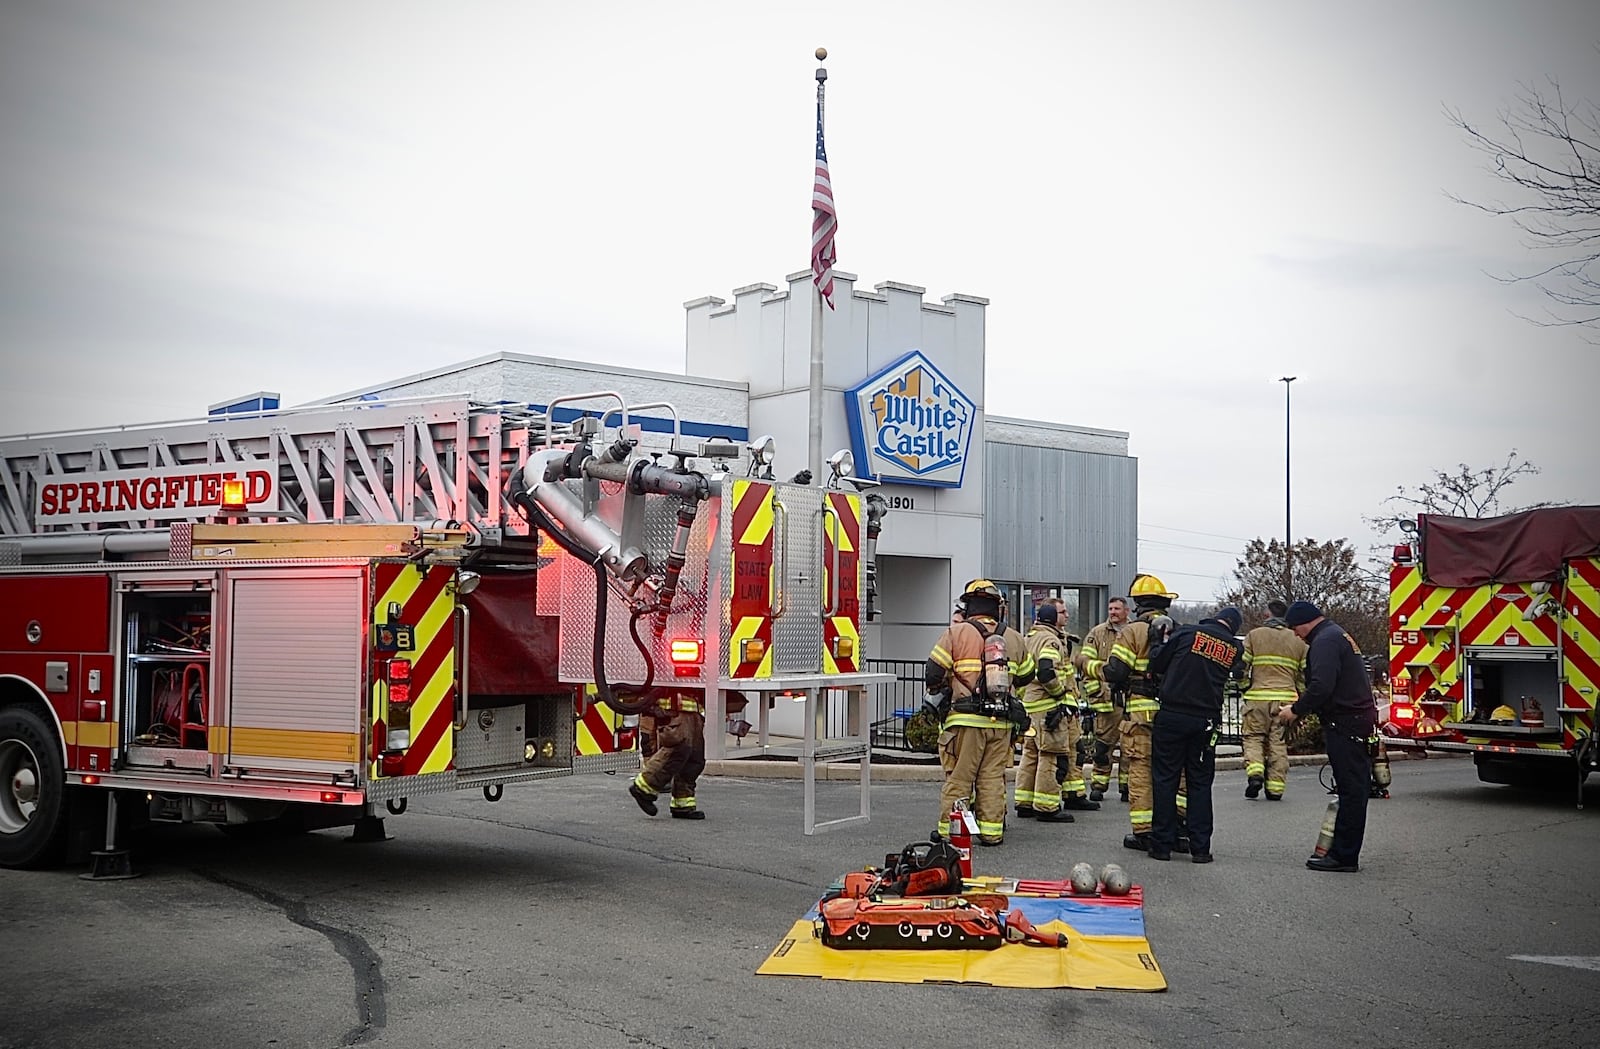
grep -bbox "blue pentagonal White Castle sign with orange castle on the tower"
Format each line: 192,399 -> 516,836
845,350 -> 978,488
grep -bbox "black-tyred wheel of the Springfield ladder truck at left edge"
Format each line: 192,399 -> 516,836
0,707 -> 67,867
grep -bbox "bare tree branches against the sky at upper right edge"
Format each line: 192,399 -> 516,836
1445,78 -> 1600,342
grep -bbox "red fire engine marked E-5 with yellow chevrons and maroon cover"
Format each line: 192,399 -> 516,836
1384,507 -> 1600,804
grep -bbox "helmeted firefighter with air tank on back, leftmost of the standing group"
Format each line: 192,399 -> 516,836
925,579 -> 1034,846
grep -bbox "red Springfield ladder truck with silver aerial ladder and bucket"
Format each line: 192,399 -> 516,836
0,392 -> 885,876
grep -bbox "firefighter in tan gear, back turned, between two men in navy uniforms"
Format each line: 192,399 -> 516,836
1242,601 -> 1306,801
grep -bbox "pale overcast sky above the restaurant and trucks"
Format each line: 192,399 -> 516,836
0,0 -> 1600,598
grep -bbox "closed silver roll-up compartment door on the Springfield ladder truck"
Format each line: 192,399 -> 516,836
229,576 -> 365,734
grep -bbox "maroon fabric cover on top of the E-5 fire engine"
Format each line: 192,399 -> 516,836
1418,507 -> 1600,587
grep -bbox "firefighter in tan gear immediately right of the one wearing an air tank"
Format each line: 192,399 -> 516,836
1016,601 -> 1099,824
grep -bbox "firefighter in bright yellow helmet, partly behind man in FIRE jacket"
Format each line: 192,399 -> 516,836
1101,574 -> 1187,852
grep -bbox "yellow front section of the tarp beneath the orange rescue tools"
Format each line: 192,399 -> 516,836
755,899 -> 1166,991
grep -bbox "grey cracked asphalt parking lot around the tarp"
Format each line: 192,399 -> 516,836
0,760 -> 1600,1049
